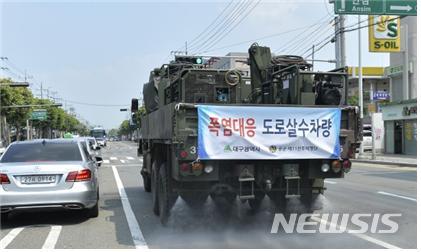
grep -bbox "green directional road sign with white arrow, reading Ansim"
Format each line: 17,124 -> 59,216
335,0 -> 417,16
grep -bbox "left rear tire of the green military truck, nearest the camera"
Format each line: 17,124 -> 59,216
158,163 -> 177,225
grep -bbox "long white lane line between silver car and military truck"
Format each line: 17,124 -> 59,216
111,165 -> 148,249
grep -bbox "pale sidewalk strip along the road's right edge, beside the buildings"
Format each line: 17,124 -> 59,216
352,153 -> 417,167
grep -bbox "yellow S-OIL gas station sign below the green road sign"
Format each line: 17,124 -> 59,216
368,16 -> 401,52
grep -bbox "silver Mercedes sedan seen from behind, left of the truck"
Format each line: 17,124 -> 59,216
0,139 -> 102,218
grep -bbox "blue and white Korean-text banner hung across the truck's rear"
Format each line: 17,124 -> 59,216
197,105 -> 341,160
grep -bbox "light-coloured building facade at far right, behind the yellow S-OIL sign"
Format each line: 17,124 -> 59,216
380,17 -> 417,155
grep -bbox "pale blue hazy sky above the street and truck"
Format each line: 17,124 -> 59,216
0,0 -> 389,129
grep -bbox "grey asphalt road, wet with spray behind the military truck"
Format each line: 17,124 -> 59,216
0,142 -> 417,249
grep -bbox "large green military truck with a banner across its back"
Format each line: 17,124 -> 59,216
138,44 -> 361,224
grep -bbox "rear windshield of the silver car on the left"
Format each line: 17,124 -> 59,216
1,142 -> 82,163
